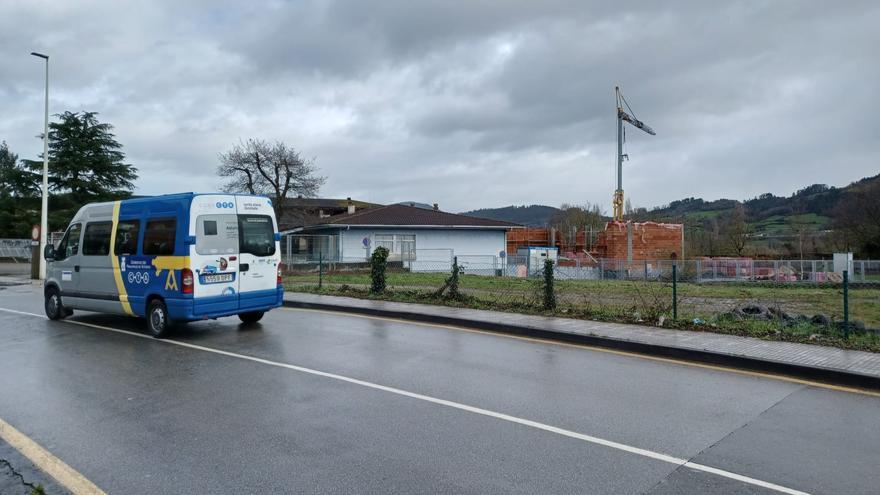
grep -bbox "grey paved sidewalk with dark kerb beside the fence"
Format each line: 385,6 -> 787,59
284,292 -> 880,390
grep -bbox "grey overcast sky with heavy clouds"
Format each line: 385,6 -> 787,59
0,0 -> 880,213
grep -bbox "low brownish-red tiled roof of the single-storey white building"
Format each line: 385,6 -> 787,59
305,205 -> 521,229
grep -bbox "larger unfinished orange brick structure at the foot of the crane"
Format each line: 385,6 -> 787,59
591,221 -> 684,260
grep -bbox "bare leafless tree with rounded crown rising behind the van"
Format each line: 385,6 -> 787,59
217,139 -> 327,219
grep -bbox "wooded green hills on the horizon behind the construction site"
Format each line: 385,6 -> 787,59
464,174 -> 880,257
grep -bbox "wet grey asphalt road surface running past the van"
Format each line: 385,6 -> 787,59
0,286 -> 880,494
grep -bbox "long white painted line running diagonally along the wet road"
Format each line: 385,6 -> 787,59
0,308 -> 808,495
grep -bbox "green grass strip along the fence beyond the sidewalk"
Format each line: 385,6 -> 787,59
285,280 -> 880,352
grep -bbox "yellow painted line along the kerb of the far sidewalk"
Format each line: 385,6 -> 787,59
281,307 -> 880,397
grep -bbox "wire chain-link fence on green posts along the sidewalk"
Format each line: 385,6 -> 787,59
285,250 -> 880,351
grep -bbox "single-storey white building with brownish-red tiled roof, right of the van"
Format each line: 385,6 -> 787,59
285,204 -> 520,271
